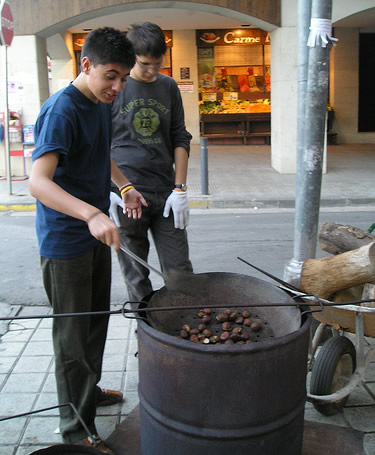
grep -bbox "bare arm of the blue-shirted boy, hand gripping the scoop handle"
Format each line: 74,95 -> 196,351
29,152 -> 120,251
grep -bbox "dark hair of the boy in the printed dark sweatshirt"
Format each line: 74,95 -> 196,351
126,22 -> 167,58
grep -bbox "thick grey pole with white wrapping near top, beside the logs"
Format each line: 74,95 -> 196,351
284,0 -> 332,287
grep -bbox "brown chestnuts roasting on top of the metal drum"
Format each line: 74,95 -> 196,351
178,308 -> 262,344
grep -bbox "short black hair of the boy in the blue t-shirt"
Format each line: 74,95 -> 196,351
81,27 -> 135,69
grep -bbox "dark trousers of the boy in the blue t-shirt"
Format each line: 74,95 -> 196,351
41,244 -> 111,443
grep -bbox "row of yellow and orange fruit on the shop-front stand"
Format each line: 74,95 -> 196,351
199,99 -> 271,114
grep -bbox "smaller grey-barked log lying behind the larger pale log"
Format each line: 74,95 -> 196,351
318,221 -> 375,254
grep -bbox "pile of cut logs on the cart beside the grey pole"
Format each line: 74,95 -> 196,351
299,221 -> 375,307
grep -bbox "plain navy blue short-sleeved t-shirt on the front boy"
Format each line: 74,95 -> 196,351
32,85 -> 111,259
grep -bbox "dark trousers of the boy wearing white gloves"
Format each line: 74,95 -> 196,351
118,191 -> 193,301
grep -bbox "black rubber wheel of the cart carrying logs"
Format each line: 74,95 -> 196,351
310,336 -> 356,416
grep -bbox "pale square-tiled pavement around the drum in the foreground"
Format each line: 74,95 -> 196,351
0,307 -> 375,455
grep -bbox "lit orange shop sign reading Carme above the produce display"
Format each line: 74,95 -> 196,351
196,28 -> 270,47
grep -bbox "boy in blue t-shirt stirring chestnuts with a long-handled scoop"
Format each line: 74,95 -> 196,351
29,27 -> 147,454
